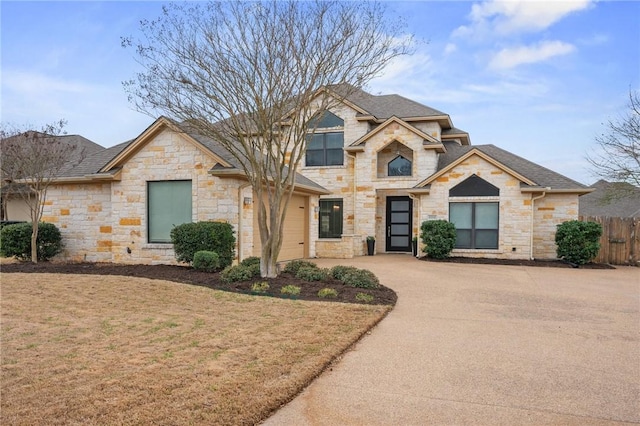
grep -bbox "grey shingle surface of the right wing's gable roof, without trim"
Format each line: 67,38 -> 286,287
438,142 -> 587,190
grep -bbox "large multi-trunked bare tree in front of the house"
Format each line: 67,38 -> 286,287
123,0 -> 412,277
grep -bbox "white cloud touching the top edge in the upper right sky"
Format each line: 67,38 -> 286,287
454,0 -> 593,37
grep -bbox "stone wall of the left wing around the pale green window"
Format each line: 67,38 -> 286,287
43,130 -> 248,264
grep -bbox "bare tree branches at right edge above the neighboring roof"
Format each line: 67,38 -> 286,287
587,91 -> 640,187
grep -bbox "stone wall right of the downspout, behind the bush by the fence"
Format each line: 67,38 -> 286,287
533,194 -> 579,259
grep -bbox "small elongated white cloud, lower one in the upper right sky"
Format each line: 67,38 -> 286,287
489,41 -> 575,69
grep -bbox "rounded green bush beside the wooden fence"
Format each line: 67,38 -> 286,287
556,220 -> 602,265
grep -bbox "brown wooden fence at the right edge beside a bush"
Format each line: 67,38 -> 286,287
580,216 -> 640,266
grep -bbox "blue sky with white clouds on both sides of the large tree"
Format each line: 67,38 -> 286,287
0,0 -> 640,184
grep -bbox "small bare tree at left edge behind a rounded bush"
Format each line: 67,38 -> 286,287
0,120 -> 82,263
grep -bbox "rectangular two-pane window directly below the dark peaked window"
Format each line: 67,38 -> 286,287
449,203 -> 499,249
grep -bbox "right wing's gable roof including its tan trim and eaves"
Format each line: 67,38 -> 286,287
417,142 -> 592,194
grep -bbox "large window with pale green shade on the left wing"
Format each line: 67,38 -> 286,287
147,180 -> 192,243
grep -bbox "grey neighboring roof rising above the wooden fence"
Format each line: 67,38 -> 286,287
579,180 -> 640,217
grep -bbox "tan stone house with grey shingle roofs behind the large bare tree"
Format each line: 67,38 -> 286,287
7,88 -> 591,263
